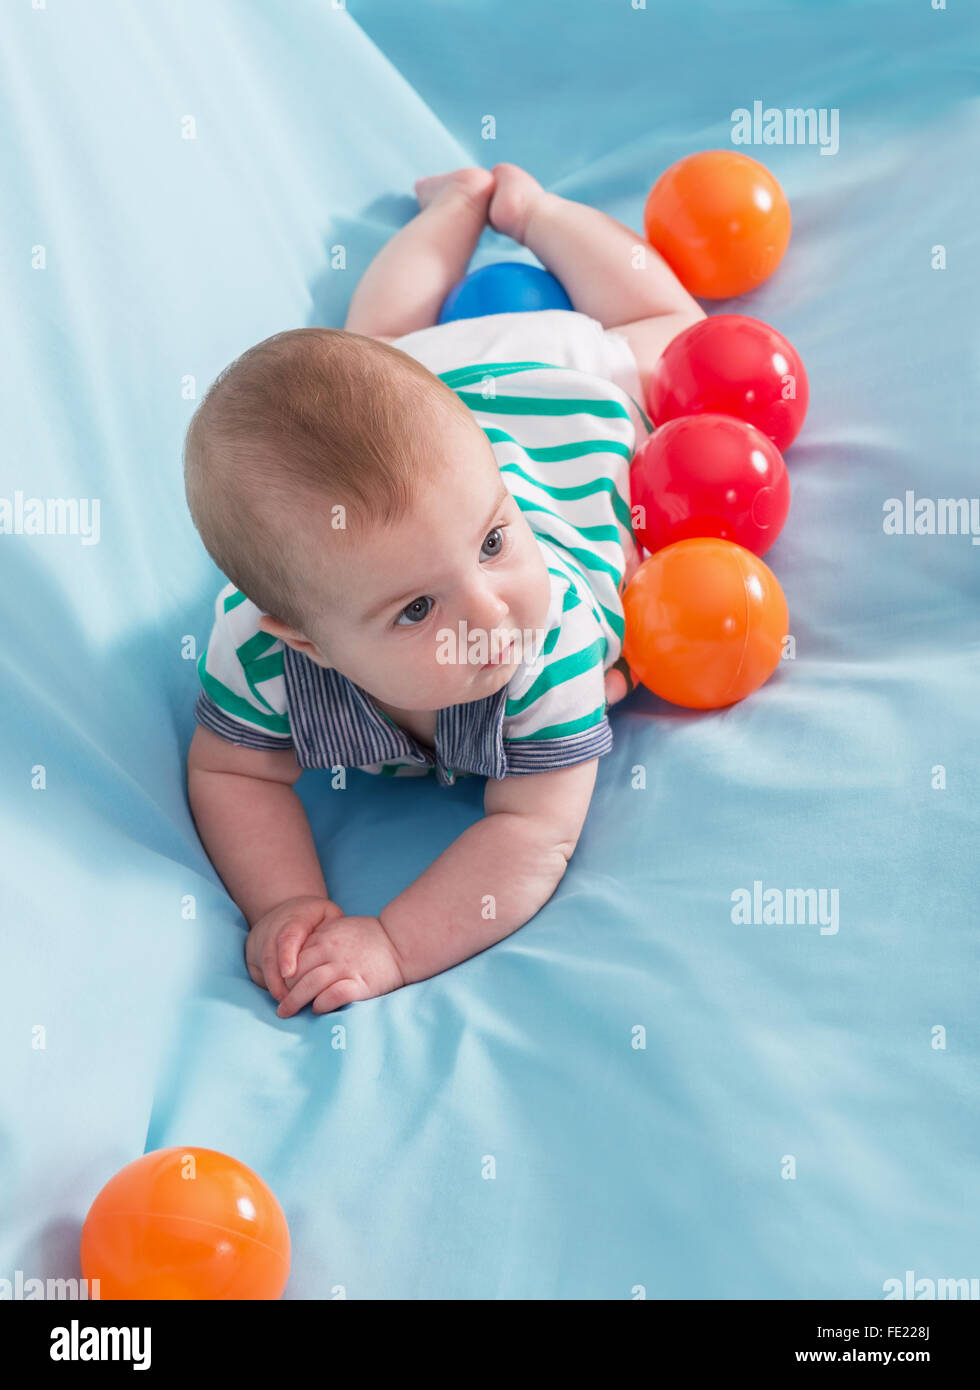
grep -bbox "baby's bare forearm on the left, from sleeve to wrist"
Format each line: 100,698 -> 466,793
188,724 -> 328,927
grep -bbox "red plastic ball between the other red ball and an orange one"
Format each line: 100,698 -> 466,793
630,416 -> 790,555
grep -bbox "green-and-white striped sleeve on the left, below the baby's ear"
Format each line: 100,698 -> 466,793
195,584 -> 293,749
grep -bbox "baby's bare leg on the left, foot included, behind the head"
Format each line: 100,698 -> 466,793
343,168 -> 495,338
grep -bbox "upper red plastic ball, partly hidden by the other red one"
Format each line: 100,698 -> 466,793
646,314 -> 810,452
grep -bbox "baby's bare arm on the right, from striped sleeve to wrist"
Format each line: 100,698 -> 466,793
378,758 -> 599,984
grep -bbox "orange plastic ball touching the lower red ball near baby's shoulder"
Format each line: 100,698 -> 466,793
623,537 -> 790,709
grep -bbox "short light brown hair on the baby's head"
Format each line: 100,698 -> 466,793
183,328 -> 474,637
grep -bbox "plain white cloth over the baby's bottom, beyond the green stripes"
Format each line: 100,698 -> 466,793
393,309 -> 642,400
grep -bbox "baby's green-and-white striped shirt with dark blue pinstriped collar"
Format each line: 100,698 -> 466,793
195,309 -> 652,785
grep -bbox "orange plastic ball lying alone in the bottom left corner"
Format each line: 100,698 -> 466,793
82,1148 -> 289,1298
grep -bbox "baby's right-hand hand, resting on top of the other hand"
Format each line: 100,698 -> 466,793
277,916 -> 406,1019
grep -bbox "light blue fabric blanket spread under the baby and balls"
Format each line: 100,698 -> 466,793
0,0 -> 980,1300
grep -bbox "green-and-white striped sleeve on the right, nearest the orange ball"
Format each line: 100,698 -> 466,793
503,569 -> 613,777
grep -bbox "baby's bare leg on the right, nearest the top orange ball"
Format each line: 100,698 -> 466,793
489,164 -> 705,328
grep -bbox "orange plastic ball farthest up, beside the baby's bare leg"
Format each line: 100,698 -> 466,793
644,150 -> 791,299
